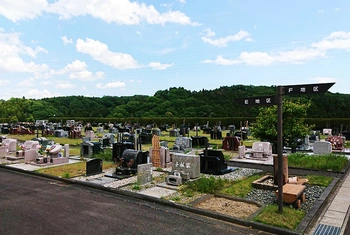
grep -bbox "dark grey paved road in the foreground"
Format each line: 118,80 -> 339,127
0,168 -> 274,235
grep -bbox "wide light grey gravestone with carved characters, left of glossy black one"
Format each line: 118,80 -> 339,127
172,153 -> 200,179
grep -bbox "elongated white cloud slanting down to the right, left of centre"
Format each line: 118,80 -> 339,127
76,38 -> 141,70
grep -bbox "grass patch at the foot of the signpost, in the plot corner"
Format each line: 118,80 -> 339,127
253,205 -> 305,230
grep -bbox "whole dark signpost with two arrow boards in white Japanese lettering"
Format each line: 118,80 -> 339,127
236,82 -> 335,214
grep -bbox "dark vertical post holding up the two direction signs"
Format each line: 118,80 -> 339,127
276,86 -> 283,214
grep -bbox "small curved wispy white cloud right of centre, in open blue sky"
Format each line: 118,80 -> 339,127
202,29 -> 252,47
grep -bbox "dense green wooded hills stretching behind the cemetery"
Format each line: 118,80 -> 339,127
0,85 -> 350,129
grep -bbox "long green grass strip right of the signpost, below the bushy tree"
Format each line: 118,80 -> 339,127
288,153 -> 349,172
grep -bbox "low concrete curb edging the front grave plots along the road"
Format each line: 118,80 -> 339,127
0,162 -> 338,235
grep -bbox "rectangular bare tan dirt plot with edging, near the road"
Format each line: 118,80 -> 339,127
196,197 -> 260,219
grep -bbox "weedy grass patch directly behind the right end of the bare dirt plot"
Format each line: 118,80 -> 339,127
220,174 -> 261,198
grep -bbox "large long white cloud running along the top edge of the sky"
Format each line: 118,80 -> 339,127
47,0 -> 199,26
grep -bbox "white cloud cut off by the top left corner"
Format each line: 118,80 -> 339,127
0,0 -> 48,22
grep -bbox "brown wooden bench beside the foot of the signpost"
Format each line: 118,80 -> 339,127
276,184 -> 306,208
